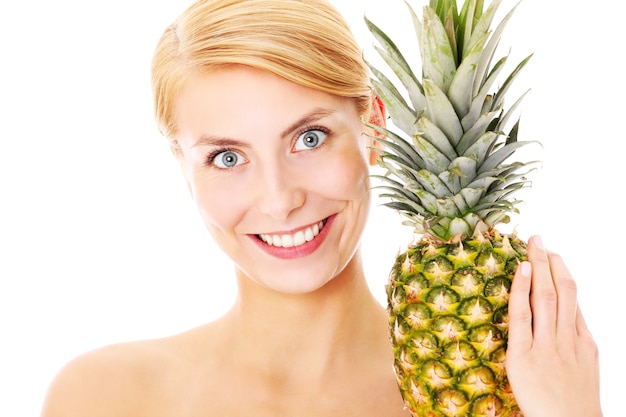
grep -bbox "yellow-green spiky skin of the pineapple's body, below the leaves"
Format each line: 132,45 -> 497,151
386,229 -> 526,417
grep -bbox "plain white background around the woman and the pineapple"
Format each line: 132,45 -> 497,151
0,0 -> 626,417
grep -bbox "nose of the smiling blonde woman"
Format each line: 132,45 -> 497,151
257,160 -> 306,220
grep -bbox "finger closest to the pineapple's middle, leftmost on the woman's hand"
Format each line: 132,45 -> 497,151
509,262 -> 533,351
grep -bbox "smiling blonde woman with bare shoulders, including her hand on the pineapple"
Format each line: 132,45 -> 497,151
42,0 -> 601,417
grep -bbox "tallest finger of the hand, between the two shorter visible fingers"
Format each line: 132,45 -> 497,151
527,236 -> 557,343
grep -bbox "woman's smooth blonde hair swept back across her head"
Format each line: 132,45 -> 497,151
152,0 -> 372,141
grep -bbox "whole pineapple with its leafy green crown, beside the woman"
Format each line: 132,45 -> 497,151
365,0 -> 537,417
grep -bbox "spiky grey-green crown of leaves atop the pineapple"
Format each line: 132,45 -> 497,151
365,0 -> 538,242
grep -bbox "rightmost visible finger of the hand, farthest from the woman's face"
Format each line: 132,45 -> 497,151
548,253 -> 578,343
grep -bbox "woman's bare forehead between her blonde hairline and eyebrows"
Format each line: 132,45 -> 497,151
175,66 -> 359,137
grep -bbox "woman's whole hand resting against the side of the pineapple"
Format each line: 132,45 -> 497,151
506,236 -> 602,417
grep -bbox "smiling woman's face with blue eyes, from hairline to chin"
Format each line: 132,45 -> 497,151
176,66 -> 369,293
